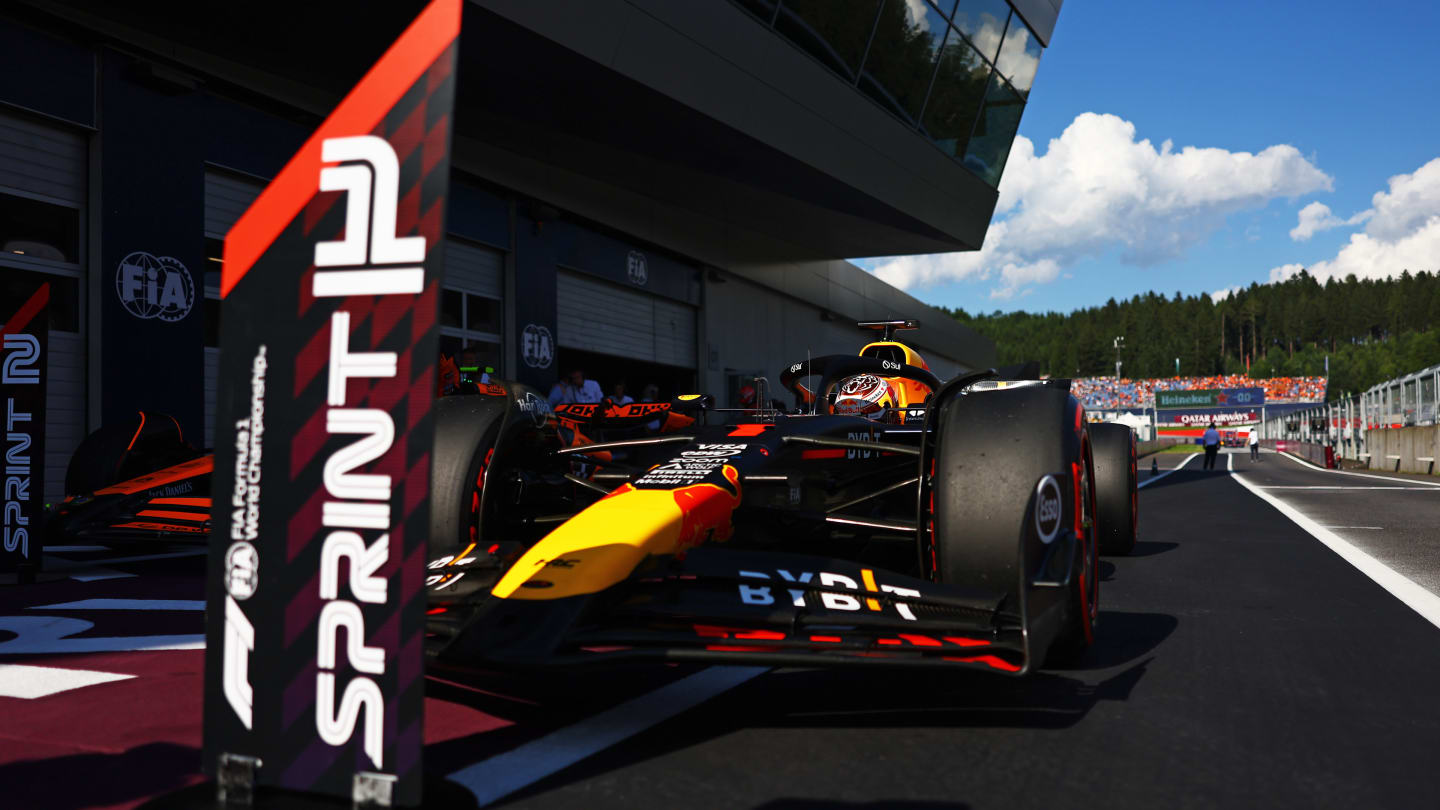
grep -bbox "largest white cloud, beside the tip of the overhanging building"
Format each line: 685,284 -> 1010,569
876,112 -> 1332,298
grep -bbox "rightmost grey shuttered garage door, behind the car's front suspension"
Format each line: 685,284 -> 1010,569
556,270 -> 696,369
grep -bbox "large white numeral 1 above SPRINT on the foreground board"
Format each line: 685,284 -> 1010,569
312,135 -> 425,297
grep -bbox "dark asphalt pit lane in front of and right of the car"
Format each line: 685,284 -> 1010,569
501,451 -> 1440,809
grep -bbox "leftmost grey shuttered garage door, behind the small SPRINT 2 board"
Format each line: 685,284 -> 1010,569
0,111 -> 86,503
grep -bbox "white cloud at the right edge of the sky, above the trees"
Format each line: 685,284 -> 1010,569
1270,157 -> 1440,282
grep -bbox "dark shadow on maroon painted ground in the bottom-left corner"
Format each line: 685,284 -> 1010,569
0,742 -> 200,810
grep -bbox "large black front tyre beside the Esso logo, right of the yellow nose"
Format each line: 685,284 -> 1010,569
922,386 -> 1099,660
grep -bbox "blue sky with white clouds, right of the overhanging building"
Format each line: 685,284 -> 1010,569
863,0 -> 1440,311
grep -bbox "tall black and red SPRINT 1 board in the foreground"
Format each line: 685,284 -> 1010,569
204,0 -> 461,806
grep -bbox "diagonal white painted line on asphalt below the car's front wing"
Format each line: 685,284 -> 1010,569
445,666 -> 769,807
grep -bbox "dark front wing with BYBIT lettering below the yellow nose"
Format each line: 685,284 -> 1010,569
429,546 -> 1030,675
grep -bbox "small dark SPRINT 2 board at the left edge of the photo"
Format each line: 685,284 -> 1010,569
0,281 -> 50,574
